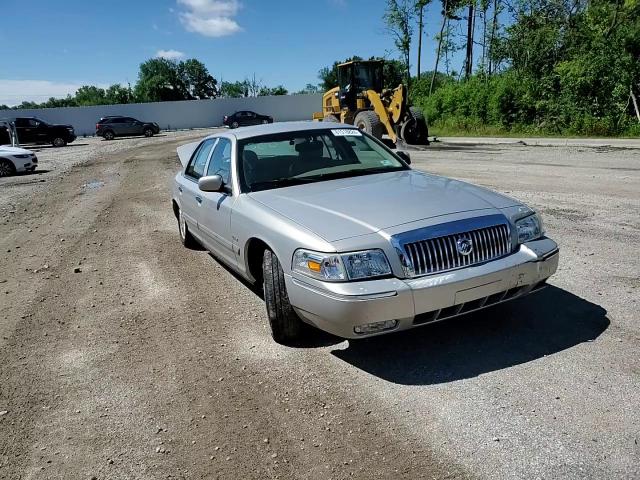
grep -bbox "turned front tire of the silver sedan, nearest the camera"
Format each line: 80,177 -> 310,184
262,250 -> 304,345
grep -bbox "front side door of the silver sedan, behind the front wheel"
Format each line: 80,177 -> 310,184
198,138 -> 236,265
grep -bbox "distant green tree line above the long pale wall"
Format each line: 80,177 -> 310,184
0,58 -> 317,109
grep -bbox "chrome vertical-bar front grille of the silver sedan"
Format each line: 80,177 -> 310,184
404,224 -> 511,276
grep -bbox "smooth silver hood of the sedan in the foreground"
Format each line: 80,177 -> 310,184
249,170 -> 519,241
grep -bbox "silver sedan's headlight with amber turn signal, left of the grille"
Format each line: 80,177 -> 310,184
292,250 -> 391,282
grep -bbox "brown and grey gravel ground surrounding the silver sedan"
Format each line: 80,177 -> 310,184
0,132 -> 640,479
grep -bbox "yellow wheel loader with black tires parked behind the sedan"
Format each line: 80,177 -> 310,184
313,60 -> 429,145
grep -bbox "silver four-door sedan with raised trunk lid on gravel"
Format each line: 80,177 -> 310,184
173,122 -> 559,344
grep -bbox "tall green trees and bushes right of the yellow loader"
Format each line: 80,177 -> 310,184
383,0 -> 640,136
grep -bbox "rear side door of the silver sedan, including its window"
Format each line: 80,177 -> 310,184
178,138 -> 217,240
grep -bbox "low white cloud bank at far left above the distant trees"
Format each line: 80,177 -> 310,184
0,79 -> 95,106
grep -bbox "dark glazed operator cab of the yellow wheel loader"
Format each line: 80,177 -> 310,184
338,61 -> 384,112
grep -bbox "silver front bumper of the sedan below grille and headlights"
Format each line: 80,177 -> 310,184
285,238 -> 559,338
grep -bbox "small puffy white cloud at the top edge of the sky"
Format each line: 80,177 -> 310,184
178,0 -> 242,37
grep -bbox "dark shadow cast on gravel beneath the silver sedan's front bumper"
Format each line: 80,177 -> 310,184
332,286 -> 610,385
